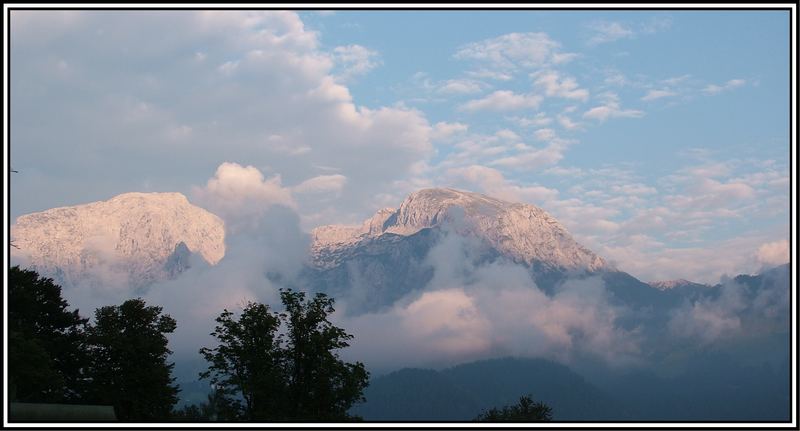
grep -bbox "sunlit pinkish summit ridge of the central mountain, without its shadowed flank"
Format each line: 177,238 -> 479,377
312,188 -> 608,272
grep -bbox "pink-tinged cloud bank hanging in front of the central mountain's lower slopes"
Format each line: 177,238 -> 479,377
342,232 -> 640,367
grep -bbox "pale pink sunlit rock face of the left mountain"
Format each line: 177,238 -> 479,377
11,193 -> 225,288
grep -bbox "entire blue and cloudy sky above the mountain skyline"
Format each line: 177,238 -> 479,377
9,10 -> 793,283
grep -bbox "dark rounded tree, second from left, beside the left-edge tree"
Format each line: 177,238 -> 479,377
88,298 -> 178,421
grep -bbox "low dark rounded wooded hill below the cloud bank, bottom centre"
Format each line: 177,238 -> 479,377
352,358 -> 623,421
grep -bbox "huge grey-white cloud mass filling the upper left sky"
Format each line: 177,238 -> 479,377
11,10 -> 433,228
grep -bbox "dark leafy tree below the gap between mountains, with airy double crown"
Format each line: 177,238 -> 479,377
200,290 -> 369,421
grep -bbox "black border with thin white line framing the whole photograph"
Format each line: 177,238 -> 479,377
0,1 -> 800,430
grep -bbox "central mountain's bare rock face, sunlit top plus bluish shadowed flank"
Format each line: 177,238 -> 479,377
303,188 -> 614,312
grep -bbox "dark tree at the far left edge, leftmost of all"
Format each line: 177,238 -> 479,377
8,266 -> 87,402
